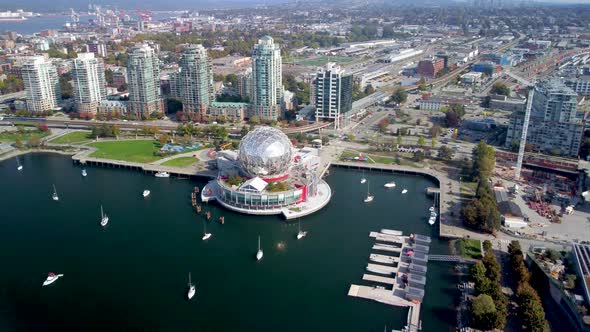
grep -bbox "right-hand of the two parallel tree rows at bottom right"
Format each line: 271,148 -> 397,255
508,241 -> 550,332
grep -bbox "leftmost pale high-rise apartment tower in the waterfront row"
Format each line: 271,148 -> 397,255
21,56 -> 61,112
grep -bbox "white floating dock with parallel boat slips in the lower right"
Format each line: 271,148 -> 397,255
348,229 -> 432,332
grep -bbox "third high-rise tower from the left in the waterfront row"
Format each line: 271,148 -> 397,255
127,44 -> 164,117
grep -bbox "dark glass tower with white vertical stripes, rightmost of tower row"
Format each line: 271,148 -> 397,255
313,62 -> 353,129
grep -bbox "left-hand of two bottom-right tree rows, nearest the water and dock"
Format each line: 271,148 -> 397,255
470,240 -> 508,331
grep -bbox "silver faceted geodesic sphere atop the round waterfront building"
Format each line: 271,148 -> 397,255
238,127 -> 294,178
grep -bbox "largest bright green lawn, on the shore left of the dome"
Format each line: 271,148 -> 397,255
89,140 -> 162,163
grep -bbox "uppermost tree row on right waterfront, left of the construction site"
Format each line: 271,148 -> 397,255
461,141 -> 501,233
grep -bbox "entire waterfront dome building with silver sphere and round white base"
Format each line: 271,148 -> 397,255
201,127 -> 331,219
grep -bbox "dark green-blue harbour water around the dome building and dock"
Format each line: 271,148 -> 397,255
0,154 -> 456,331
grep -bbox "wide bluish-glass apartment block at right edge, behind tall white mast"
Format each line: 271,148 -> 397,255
506,80 -> 584,157
